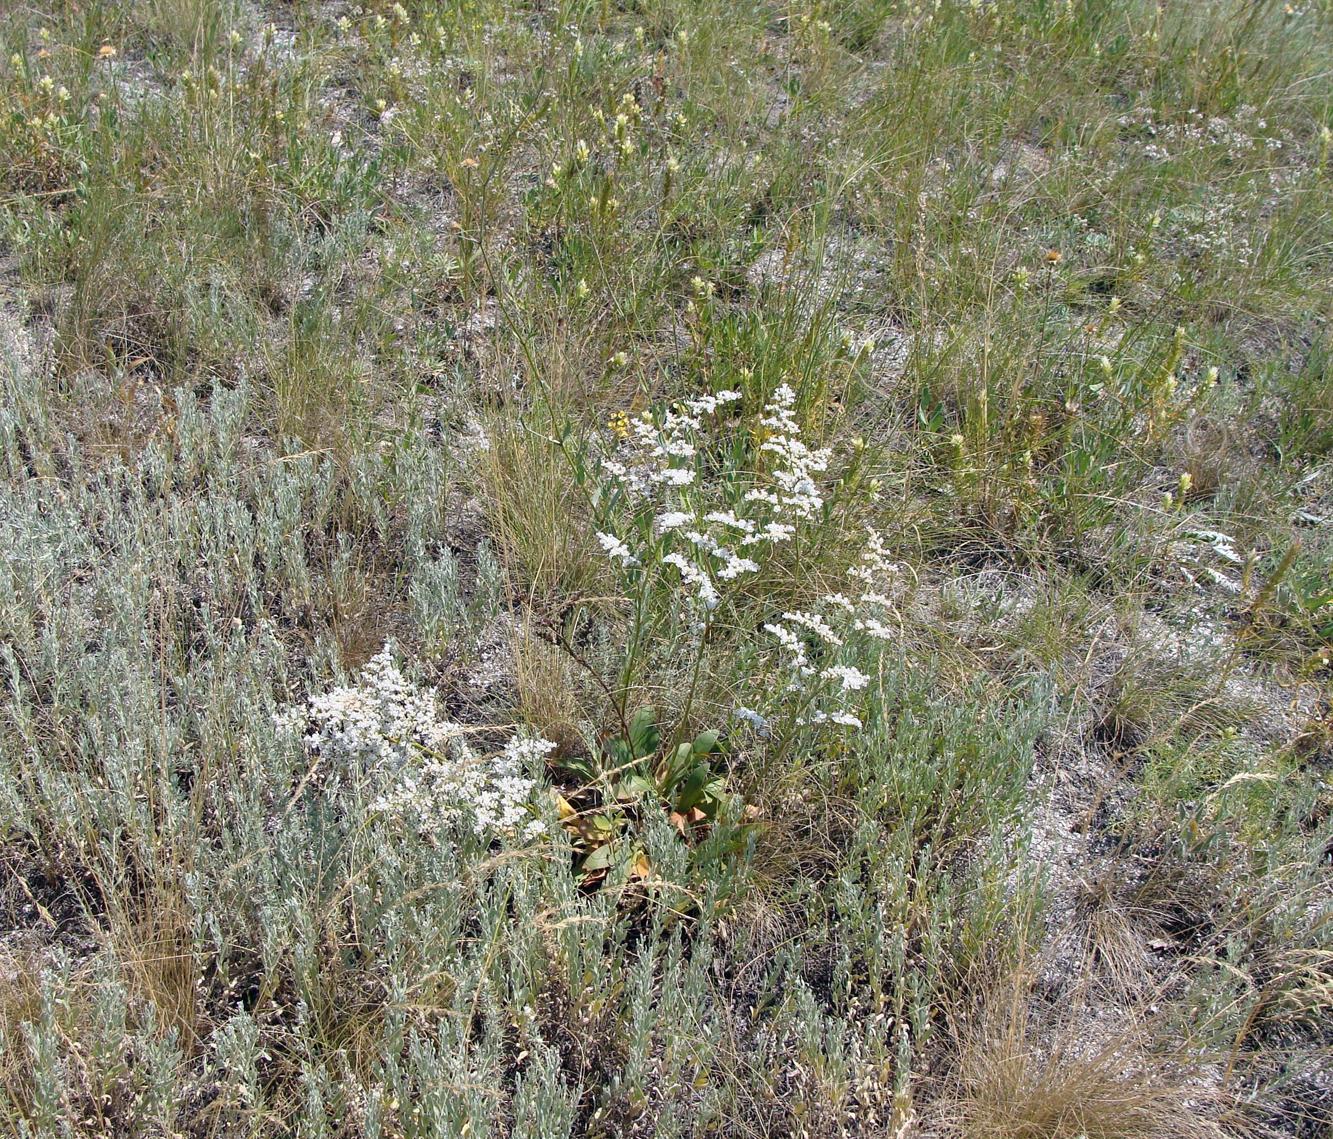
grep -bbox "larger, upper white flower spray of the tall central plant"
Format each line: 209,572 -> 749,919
597,384 -> 830,612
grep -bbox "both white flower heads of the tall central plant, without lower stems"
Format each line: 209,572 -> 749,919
597,384 -> 896,736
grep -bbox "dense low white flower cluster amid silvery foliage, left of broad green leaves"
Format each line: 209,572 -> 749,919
275,646 -> 555,838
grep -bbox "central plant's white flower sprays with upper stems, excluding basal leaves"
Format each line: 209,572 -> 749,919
579,384 -> 897,752
